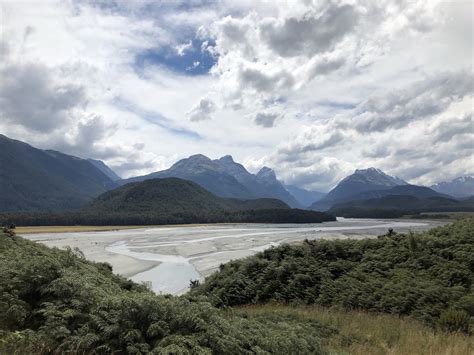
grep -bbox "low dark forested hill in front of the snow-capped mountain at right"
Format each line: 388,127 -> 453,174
328,195 -> 474,218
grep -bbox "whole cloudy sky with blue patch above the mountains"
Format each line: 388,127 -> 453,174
0,0 -> 474,191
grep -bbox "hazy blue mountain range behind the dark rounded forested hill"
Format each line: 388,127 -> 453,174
0,135 -> 474,212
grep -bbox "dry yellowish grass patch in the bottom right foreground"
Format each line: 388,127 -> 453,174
235,304 -> 474,355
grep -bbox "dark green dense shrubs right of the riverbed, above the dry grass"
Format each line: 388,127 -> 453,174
192,218 -> 474,331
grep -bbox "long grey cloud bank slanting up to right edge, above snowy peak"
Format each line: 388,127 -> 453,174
353,71 -> 474,132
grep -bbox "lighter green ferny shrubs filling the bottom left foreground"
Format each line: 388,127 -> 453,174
0,229 -> 334,354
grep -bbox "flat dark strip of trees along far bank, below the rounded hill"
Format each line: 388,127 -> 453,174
0,209 -> 336,226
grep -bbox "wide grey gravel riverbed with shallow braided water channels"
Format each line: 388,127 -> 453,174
24,218 -> 445,294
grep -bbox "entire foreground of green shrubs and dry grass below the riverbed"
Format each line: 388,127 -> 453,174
0,219 -> 474,354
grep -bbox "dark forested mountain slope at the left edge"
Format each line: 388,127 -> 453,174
0,134 -> 114,212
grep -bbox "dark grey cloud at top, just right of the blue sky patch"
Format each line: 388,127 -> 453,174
260,2 -> 359,57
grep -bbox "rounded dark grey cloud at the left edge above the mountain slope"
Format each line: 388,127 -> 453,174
0,64 -> 87,133
